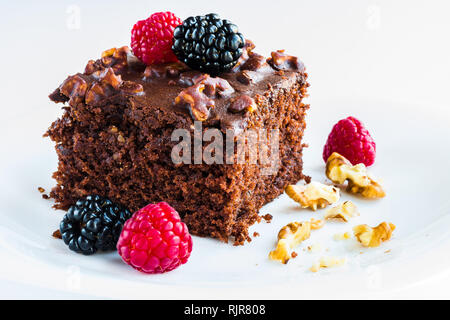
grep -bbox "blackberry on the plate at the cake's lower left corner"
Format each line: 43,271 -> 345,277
59,195 -> 131,255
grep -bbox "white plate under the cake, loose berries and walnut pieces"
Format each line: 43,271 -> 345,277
0,100 -> 450,299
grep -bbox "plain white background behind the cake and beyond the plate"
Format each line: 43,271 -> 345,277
0,0 -> 450,298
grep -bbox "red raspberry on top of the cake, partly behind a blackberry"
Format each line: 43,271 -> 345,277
131,12 -> 182,65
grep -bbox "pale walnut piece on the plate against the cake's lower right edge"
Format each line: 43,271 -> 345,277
285,181 -> 340,211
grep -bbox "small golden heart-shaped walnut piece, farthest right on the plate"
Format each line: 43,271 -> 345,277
353,222 -> 395,248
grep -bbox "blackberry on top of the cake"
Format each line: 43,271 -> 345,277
172,13 -> 245,75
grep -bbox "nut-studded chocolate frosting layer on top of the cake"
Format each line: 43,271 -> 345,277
50,41 -> 306,129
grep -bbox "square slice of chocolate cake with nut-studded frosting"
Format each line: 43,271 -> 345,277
45,42 -> 308,244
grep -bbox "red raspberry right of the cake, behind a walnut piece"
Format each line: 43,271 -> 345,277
323,117 -> 376,166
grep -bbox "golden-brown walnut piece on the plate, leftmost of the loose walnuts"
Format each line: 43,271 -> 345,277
269,222 -> 311,264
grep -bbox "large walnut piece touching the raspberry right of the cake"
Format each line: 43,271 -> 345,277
326,152 -> 386,199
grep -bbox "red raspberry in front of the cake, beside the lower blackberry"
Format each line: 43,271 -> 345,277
117,202 -> 192,273
